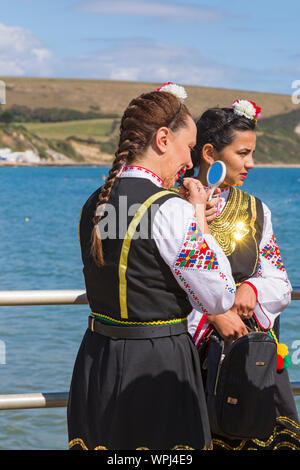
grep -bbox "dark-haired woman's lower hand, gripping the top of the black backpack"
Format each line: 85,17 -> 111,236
207,310 -> 248,341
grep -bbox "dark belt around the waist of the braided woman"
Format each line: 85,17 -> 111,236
89,316 -> 187,339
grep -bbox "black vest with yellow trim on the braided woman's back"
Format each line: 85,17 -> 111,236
79,178 -> 192,323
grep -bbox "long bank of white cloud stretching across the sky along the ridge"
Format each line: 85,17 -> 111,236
0,23 -> 288,93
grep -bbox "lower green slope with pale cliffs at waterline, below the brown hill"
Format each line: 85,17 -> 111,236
0,109 -> 300,164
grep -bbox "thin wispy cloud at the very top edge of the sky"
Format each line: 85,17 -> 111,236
78,0 -> 224,22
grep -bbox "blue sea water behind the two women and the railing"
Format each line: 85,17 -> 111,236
0,167 -> 300,450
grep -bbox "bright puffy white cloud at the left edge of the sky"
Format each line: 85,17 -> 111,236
0,23 -> 53,76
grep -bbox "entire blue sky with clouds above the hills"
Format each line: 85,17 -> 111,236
0,0 -> 300,94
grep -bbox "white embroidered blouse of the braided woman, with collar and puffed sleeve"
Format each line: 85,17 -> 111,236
118,166 -> 235,318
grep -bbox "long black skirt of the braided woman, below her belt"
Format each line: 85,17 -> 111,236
68,329 -> 211,450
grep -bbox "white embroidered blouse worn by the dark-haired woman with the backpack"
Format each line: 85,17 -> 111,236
188,188 -> 292,346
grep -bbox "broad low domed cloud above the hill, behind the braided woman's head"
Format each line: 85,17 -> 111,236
55,38 -> 232,86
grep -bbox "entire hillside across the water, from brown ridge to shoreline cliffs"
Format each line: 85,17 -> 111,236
0,77 -> 300,164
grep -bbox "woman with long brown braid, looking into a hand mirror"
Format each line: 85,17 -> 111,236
68,84 -> 235,450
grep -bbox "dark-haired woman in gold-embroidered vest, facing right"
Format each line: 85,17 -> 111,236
188,100 -> 300,449
